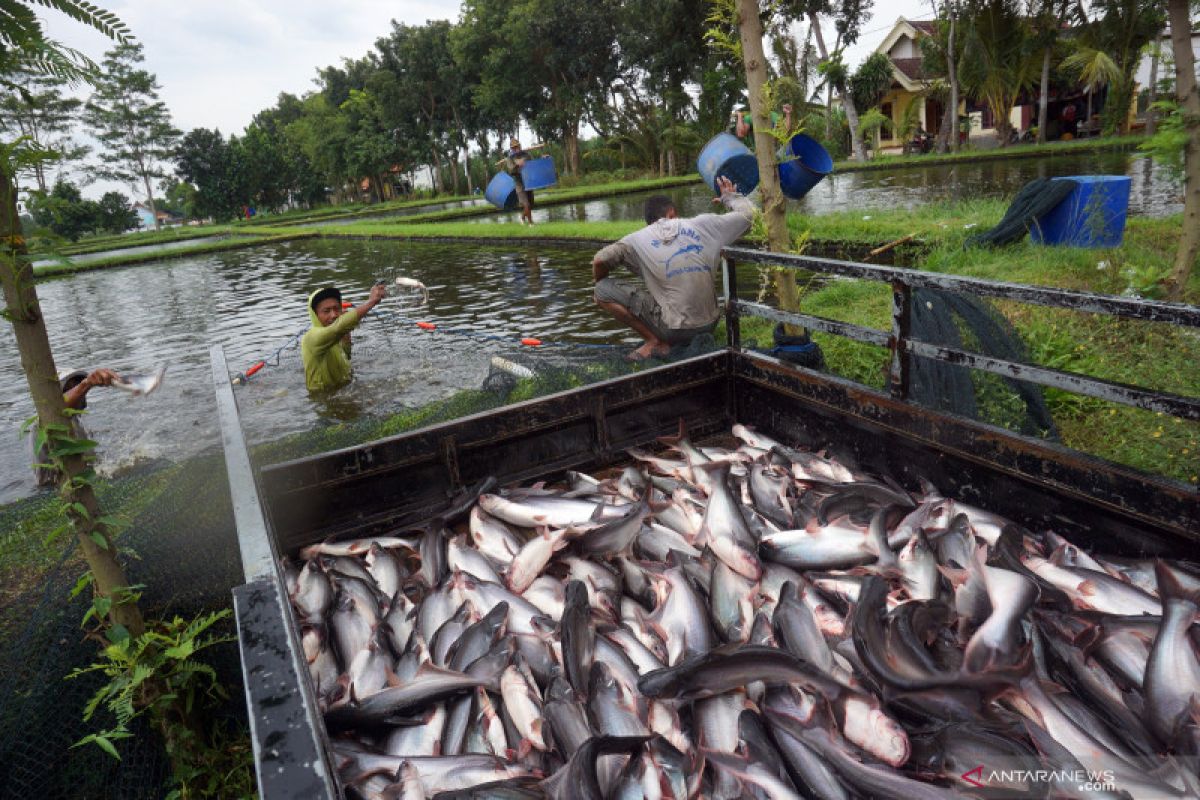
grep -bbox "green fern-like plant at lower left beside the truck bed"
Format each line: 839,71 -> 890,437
67,606 -> 254,799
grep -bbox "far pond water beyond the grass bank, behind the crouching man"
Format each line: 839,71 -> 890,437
463,152 -> 1183,224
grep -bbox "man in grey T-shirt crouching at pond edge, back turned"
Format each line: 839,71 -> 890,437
592,178 -> 754,361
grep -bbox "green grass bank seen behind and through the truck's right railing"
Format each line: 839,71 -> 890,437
743,200 -> 1200,485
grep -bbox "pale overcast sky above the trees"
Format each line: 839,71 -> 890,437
35,0 -> 931,194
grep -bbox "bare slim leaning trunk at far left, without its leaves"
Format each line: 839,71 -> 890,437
0,176 -> 144,636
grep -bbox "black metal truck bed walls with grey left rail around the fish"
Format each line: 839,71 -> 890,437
214,350 -> 1200,799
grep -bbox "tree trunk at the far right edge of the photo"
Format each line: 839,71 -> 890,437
1166,0 -> 1200,301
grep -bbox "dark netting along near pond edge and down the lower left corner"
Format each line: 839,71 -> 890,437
0,323 -> 716,799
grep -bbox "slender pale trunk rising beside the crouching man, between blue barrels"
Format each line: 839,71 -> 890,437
738,0 -> 799,319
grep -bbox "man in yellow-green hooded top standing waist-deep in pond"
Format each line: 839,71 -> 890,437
300,283 -> 388,392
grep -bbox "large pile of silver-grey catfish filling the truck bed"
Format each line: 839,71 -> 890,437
284,426 -> 1200,800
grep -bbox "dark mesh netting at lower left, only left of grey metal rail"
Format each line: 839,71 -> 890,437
0,453 -> 245,799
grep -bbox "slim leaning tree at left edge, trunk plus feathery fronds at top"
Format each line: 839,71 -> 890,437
0,0 -> 143,636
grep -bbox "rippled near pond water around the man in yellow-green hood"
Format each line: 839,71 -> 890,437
0,240 -> 756,503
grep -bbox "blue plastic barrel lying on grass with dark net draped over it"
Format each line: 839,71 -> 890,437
1030,175 -> 1130,247
